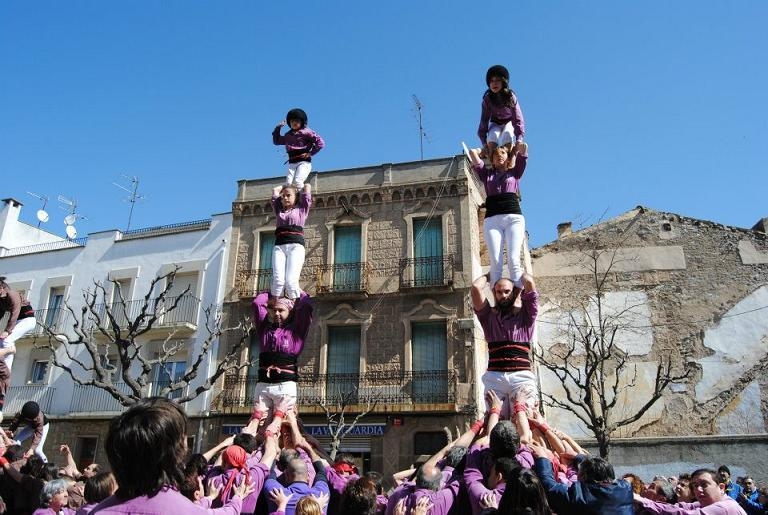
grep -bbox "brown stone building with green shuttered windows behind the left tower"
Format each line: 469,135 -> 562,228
211,156 -> 485,480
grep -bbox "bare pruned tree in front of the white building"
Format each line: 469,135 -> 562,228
35,266 -> 249,406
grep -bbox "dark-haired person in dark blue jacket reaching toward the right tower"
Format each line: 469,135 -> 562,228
531,443 -> 637,515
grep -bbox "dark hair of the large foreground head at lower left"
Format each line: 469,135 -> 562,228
104,397 -> 187,499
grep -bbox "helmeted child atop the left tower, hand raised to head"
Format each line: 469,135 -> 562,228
272,108 -> 325,190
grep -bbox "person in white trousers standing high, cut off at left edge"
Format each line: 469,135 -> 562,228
0,277 -> 37,422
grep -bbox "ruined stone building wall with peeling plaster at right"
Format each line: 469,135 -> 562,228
531,207 -> 768,478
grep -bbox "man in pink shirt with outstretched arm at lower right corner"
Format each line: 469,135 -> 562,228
635,468 -> 745,515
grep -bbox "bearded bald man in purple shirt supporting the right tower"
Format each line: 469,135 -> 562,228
471,274 -> 539,419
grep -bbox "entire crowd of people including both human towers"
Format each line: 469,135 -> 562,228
0,65 -> 768,515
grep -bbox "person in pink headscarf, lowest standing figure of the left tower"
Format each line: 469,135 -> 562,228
243,292 -> 312,435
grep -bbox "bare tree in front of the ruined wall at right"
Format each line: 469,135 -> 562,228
534,238 -> 691,459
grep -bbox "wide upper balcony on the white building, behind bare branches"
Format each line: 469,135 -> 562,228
94,295 -> 200,337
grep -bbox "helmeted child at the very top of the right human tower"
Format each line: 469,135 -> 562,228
477,64 -> 525,157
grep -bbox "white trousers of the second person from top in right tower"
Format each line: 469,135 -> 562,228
483,214 -> 525,288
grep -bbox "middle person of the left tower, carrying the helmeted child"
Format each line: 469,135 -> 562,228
270,184 -> 312,300
